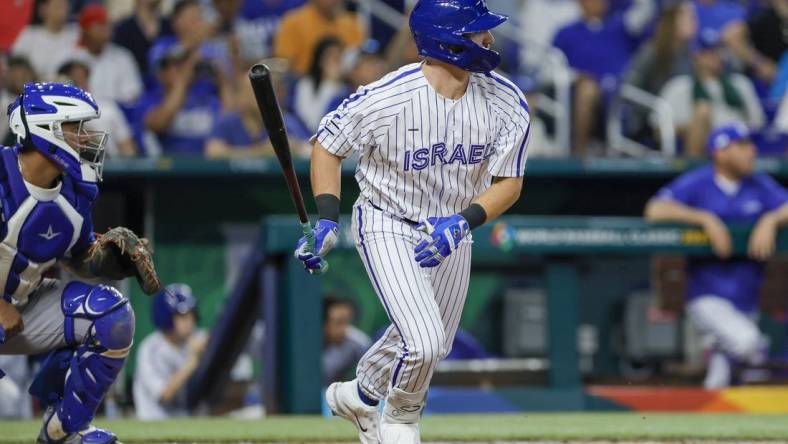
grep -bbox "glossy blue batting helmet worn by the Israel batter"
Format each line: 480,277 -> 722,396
410,0 -> 507,72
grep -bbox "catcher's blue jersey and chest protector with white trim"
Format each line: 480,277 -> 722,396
0,146 -> 98,305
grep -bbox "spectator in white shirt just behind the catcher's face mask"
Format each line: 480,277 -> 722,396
58,60 -> 137,158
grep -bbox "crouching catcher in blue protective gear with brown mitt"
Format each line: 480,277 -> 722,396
0,83 -> 161,444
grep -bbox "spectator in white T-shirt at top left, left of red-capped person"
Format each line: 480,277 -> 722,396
12,0 -> 79,80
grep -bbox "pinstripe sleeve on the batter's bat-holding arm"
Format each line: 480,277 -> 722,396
315,87 -> 369,158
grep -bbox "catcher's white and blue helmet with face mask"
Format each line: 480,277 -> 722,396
8,83 -> 107,182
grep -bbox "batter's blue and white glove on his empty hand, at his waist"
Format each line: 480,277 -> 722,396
413,214 -> 471,268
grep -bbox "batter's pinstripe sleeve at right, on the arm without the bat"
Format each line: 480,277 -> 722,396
489,110 -> 531,177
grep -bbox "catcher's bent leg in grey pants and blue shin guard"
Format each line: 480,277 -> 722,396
0,281 -> 134,443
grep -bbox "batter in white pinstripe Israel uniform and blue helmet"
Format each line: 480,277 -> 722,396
296,0 -> 530,444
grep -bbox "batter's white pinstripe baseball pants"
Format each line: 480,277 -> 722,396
353,202 -> 473,399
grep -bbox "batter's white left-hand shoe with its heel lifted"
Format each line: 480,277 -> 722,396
326,379 -> 380,444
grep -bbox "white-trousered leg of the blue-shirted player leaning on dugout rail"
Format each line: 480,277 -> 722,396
687,296 -> 765,388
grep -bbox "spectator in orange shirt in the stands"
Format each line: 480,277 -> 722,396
274,0 -> 366,75
